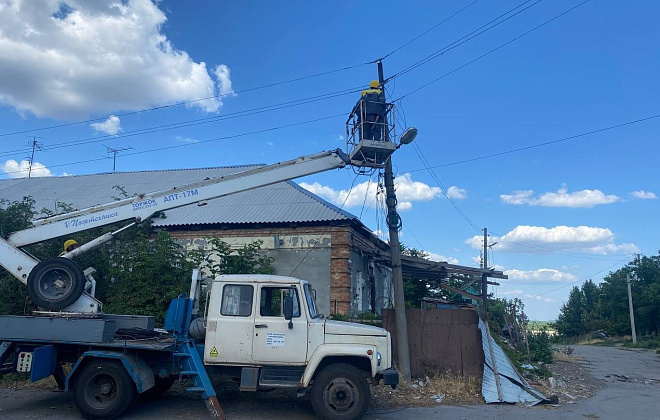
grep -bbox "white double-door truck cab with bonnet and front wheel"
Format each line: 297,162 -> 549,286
203,275 -> 398,418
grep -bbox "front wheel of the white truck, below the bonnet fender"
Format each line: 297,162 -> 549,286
312,363 -> 370,420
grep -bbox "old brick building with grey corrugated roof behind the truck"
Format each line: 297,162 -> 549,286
0,166 -> 393,314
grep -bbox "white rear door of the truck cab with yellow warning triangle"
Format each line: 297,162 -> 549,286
204,283 -> 255,364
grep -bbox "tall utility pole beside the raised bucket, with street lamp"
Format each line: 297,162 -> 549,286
378,60 -> 411,381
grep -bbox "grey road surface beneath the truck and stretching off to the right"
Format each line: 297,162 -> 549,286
0,346 -> 660,420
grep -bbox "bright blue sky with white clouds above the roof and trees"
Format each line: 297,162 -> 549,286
0,0 -> 660,320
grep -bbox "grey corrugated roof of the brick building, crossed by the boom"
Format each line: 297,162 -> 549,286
0,165 -> 355,226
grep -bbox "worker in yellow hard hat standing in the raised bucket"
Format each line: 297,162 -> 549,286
353,80 -> 387,141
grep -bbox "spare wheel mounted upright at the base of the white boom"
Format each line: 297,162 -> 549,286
27,258 -> 85,311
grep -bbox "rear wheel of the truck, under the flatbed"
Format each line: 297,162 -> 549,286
73,360 -> 137,419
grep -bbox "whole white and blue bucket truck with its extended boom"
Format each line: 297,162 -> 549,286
0,140 -> 398,420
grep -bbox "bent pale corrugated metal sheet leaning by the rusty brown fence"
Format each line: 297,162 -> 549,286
479,319 -> 546,406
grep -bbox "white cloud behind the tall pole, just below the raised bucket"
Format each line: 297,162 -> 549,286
300,174 -> 442,211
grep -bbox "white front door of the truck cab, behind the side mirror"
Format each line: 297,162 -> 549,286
252,283 -> 307,364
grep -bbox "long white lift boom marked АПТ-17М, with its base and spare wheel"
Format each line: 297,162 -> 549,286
0,142 -> 396,313
